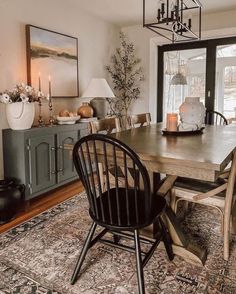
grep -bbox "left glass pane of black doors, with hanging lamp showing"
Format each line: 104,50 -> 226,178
163,48 -> 206,118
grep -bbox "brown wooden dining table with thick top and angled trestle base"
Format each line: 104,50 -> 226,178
65,123 -> 236,265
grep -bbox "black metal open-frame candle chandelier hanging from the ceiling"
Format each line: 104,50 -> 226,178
143,0 -> 202,43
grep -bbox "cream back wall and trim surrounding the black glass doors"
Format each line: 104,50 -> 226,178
122,9 -> 236,121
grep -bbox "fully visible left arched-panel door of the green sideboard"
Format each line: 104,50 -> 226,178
27,135 -> 56,194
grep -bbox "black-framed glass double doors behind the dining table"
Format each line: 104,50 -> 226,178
157,37 -> 236,122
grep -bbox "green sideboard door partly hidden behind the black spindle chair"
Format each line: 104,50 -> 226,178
57,131 -> 79,183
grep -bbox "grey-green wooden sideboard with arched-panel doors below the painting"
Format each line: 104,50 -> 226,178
2,123 -> 89,200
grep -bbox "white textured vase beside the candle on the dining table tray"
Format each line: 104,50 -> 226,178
179,97 -> 206,129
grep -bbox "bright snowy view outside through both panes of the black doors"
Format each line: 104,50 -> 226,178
163,44 -> 236,118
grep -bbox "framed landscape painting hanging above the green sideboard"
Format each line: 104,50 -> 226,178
26,25 -> 79,97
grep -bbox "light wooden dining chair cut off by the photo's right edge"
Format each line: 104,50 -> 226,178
171,151 -> 236,260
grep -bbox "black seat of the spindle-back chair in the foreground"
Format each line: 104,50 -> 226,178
90,188 -> 166,230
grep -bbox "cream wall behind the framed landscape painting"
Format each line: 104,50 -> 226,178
0,0 -> 119,178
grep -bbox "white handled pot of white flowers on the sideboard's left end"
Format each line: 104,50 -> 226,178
0,83 -> 40,130
